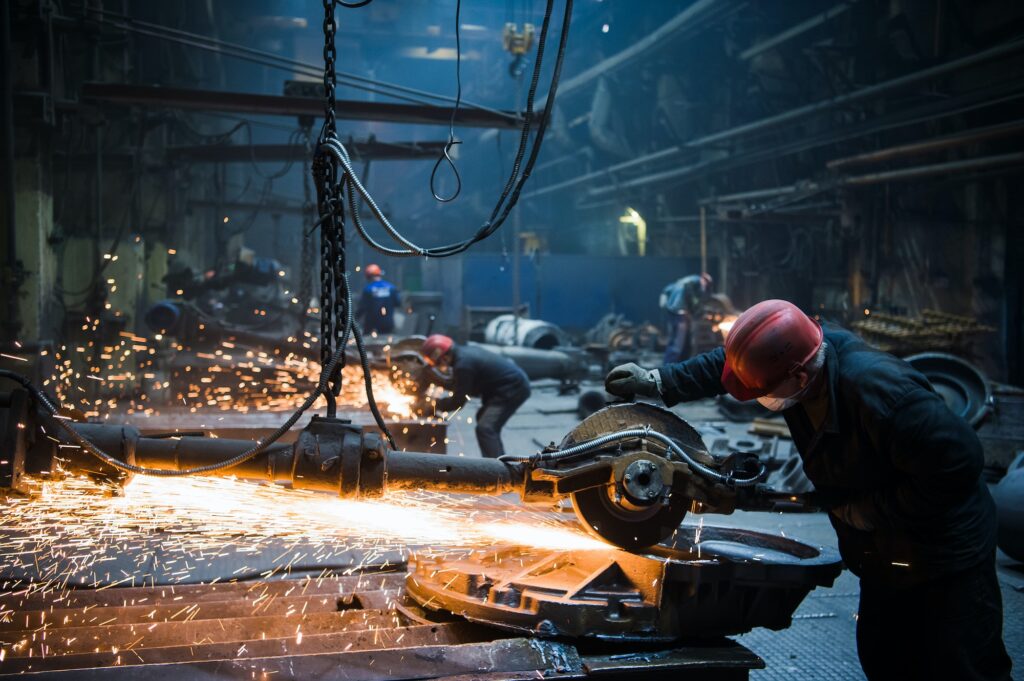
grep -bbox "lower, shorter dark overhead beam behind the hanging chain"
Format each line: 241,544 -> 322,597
167,140 -> 445,163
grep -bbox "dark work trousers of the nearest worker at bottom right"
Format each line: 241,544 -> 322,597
857,555 -> 1011,681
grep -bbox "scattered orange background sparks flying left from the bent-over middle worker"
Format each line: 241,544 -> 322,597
35,317 -> 418,419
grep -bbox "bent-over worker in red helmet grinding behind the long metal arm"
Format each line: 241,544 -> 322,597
420,334 -> 529,459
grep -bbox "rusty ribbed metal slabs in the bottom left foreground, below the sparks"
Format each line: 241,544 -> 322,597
0,571 -> 763,681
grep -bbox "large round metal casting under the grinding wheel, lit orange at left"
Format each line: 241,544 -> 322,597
406,526 -> 842,641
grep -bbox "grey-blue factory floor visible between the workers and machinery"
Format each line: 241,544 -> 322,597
449,382 -> 1024,681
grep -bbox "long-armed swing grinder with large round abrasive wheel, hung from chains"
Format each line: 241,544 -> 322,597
6,397 -> 790,550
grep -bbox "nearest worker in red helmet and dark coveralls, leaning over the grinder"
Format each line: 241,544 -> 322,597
606,300 -> 1011,681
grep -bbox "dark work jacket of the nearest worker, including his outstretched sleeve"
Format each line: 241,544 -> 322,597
660,326 -> 995,587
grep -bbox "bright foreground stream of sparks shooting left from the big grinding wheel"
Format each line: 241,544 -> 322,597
0,476 -> 616,659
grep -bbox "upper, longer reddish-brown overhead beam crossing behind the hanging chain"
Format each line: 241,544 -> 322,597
81,83 -> 522,129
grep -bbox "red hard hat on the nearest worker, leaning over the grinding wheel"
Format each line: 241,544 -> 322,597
722,300 -> 823,401
